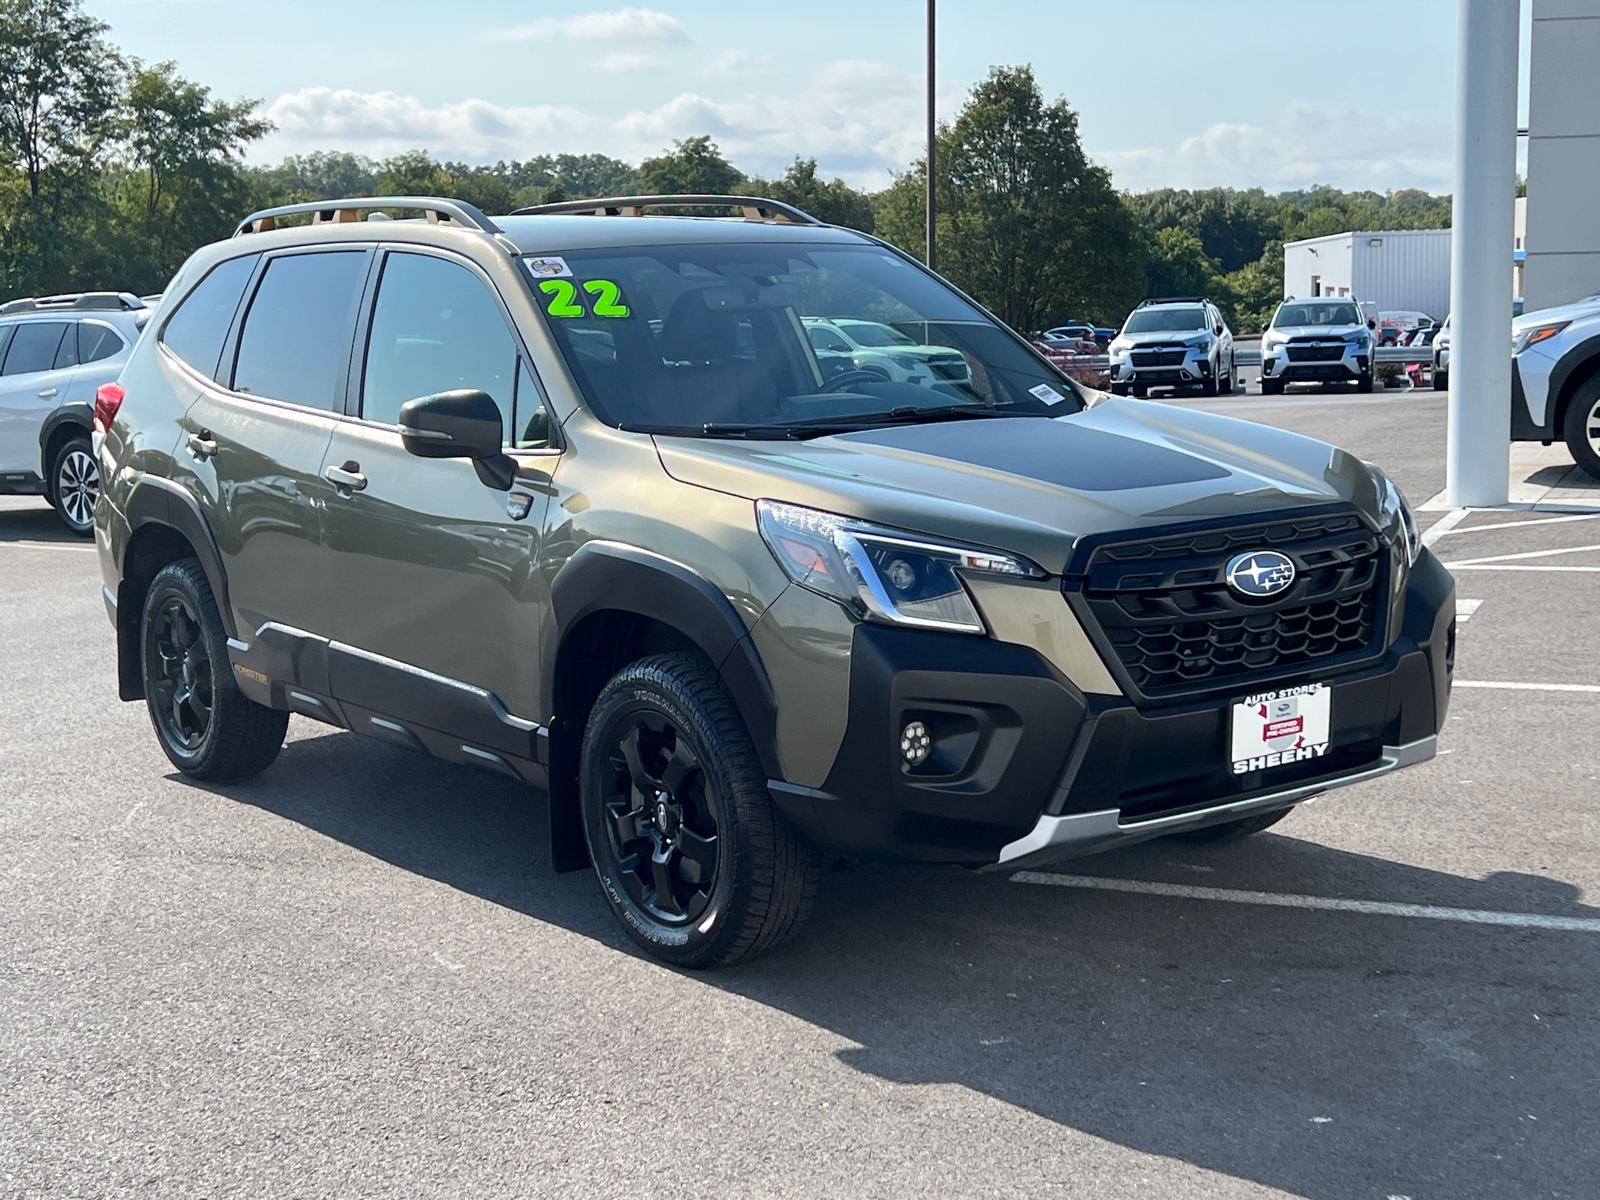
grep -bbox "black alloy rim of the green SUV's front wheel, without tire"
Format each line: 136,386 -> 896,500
603,710 -> 717,925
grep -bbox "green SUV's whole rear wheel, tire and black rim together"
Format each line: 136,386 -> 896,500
139,558 -> 290,782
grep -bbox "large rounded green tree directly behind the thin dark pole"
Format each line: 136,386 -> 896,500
877,67 -> 1144,330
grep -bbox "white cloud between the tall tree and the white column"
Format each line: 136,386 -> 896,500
1090,104 -> 1453,192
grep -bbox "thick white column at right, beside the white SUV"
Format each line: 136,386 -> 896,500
1445,0 -> 1518,506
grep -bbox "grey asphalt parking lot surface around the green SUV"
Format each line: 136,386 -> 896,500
0,392 -> 1600,1200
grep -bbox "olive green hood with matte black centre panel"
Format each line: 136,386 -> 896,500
656,398 -> 1379,573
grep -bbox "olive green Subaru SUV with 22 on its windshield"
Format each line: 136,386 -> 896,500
94,197 -> 1454,966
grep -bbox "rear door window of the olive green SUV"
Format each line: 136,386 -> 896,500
234,250 -> 366,411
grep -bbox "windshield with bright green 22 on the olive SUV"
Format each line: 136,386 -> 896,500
525,243 -> 1082,437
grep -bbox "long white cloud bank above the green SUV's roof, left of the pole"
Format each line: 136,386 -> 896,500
251,61 -> 922,187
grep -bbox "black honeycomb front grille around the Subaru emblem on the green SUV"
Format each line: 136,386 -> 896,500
1066,512 -> 1387,699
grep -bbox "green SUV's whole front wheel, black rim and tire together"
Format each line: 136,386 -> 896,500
579,653 -> 822,966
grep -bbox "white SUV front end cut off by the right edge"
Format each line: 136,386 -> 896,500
1510,296 -> 1600,478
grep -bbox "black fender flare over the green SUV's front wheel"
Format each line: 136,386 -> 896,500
539,541 -> 781,778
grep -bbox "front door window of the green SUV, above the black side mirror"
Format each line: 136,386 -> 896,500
362,253 -> 517,430
